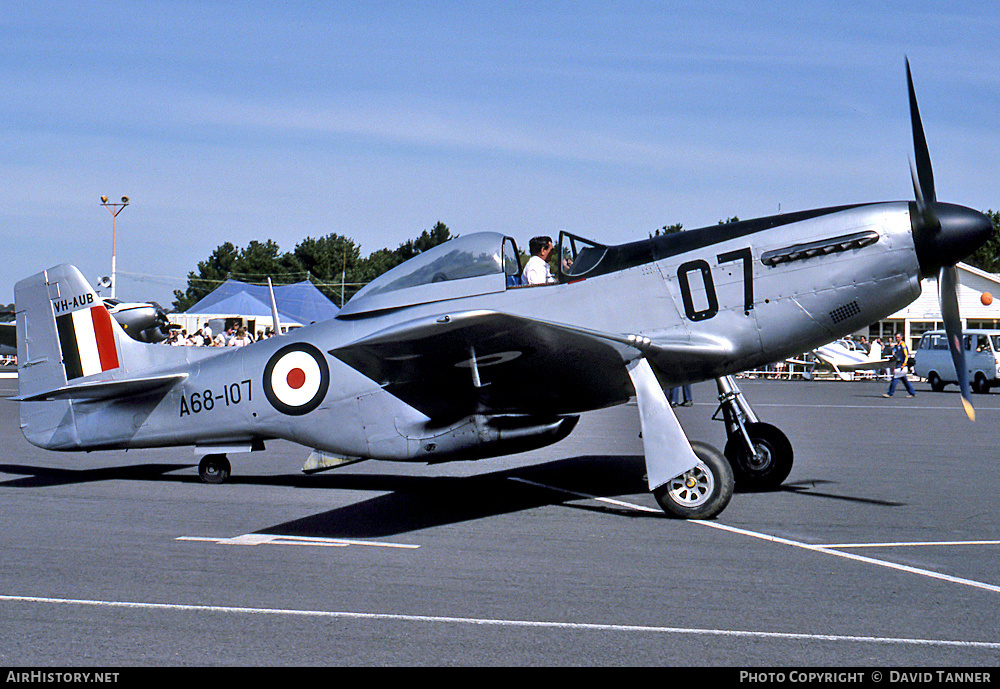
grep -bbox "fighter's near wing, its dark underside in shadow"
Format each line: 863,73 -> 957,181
330,311 -> 732,419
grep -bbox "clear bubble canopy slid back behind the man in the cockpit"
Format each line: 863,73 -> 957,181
338,232 -> 520,317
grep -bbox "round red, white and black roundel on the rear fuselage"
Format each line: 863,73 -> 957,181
263,342 -> 330,416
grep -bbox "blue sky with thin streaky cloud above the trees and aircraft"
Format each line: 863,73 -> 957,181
0,0 -> 1000,303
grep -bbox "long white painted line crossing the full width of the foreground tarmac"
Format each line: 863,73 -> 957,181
0,595 -> 1000,650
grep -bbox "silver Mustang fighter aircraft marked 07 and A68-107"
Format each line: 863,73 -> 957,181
9,65 -> 992,518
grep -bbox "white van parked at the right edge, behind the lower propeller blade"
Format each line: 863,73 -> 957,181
913,330 -> 1000,393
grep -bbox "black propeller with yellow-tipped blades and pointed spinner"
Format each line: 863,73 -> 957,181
906,60 -> 993,420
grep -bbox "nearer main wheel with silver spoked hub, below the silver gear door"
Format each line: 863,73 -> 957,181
653,441 -> 733,519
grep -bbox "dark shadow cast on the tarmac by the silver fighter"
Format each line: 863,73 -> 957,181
0,455 -> 903,538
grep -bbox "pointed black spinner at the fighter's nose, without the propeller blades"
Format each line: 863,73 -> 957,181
910,203 -> 993,277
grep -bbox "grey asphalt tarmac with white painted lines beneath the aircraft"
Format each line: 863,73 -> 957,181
0,380 -> 1000,670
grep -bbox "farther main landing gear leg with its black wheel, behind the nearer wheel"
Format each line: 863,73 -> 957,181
712,376 -> 793,491
